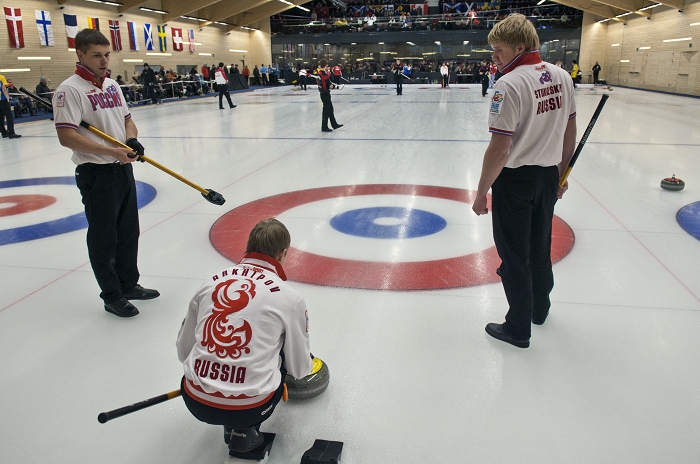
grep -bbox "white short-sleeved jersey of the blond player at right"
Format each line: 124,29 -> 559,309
489,50 -> 576,168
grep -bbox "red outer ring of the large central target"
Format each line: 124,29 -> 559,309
209,184 -> 574,290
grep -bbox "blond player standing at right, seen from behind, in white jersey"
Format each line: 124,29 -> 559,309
472,14 -> 576,348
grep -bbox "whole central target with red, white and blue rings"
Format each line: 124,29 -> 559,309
210,184 -> 574,290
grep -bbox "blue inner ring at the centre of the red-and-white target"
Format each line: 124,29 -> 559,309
331,206 -> 447,239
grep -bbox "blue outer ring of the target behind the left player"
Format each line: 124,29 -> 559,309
0,177 -> 156,246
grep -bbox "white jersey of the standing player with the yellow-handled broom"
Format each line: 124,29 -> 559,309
53,64 -> 131,164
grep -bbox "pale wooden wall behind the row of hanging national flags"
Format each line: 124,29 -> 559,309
0,0 -> 271,90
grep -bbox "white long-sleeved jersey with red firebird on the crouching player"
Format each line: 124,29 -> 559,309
176,253 -> 313,409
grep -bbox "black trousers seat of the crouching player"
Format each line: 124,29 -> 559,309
180,367 -> 287,430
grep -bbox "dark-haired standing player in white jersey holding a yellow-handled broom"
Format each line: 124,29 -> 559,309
53,29 -> 160,317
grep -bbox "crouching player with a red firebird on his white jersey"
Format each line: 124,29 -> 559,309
176,219 -> 313,453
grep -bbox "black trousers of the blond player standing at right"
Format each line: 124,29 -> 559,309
492,166 -> 559,339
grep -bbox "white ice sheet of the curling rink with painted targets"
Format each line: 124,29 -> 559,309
0,84 -> 700,464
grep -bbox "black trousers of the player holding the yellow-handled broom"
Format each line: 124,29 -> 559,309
75,163 -> 140,303
